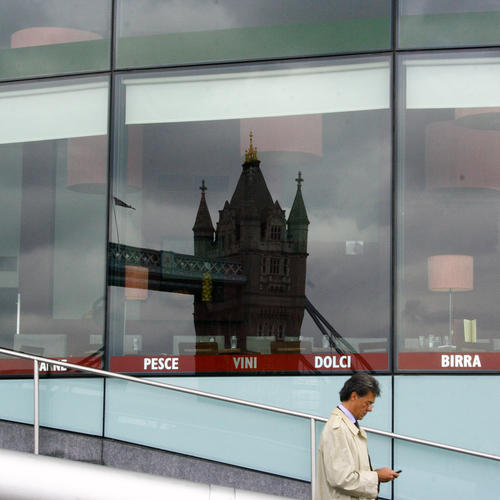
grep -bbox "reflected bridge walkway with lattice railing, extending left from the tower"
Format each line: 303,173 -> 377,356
108,243 -> 247,293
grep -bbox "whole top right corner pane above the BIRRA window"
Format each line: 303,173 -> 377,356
399,0 -> 500,48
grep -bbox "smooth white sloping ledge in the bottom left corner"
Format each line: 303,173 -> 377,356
0,450 -> 292,500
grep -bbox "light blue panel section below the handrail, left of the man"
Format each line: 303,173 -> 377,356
105,380 -> 310,480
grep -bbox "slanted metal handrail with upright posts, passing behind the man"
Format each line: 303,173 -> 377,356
0,348 -> 500,498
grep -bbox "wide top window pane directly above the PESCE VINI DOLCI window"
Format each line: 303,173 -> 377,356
117,0 -> 391,68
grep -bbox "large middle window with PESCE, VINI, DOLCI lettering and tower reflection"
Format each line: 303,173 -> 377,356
109,57 -> 391,373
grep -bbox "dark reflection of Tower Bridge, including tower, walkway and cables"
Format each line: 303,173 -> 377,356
109,134 -> 368,366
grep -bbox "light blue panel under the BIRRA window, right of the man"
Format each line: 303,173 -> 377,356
394,375 -> 500,500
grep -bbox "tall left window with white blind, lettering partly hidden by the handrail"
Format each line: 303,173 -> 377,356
0,78 -> 108,373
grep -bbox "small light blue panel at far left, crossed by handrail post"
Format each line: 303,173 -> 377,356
0,378 -> 104,435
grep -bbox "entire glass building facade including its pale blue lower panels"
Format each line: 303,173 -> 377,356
0,0 -> 500,500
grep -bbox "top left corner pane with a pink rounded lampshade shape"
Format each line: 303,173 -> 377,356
0,0 -> 111,79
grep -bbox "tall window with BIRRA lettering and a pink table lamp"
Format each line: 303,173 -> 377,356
397,53 -> 500,370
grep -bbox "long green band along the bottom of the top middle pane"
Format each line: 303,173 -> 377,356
117,17 -> 390,68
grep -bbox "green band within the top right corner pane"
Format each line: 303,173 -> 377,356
399,11 -> 500,48
